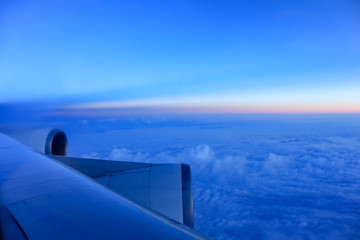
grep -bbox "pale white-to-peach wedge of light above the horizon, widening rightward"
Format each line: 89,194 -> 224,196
59,81 -> 360,114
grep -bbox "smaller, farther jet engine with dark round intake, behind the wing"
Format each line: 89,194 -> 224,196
6,128 -> 68,156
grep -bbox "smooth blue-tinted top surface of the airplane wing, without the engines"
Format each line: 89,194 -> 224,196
0,133 -> 208,240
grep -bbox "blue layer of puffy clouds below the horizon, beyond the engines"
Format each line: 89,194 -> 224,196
70,115 -> 360,239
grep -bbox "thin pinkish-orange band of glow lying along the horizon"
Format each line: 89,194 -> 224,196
53,102 -> 360,116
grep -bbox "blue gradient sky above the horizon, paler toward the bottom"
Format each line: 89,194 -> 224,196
0,0 -> 360,112
